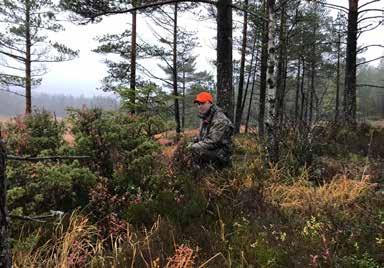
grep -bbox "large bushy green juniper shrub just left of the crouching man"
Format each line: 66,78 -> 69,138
70,109 -> 160,193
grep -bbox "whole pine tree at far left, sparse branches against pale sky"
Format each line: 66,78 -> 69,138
0,0 -> 78,114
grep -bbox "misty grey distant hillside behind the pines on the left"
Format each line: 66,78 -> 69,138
0,91 -> 119,116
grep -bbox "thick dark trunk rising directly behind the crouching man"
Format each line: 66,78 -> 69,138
217,0 -> 233,121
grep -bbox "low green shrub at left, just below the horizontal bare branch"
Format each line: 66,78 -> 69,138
7,161 -> 96,215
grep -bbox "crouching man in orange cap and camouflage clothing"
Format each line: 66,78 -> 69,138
189,91 -> 233,168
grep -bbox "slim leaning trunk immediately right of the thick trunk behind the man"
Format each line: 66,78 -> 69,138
235,0 -> 248,133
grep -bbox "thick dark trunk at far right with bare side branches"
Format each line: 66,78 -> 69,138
344,0 -> 359,125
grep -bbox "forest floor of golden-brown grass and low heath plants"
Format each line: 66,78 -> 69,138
10,116 -> 384,268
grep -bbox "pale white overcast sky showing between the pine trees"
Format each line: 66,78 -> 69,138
25,0 -> 384,96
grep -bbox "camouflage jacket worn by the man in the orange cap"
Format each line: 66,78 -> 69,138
193,105 -> 233,152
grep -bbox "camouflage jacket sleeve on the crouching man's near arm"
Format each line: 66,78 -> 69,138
193,117 -> 232,150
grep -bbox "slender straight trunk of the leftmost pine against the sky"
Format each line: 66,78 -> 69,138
25,0 -> 32,114
